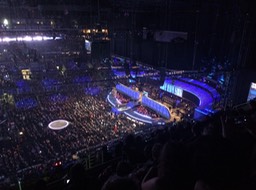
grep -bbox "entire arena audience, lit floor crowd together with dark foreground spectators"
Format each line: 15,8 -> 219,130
0,49 -> 256,190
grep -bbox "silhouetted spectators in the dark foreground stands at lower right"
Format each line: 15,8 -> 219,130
49,110 -> 256,190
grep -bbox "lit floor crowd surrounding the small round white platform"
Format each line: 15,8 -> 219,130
0,85 -> 149,184
